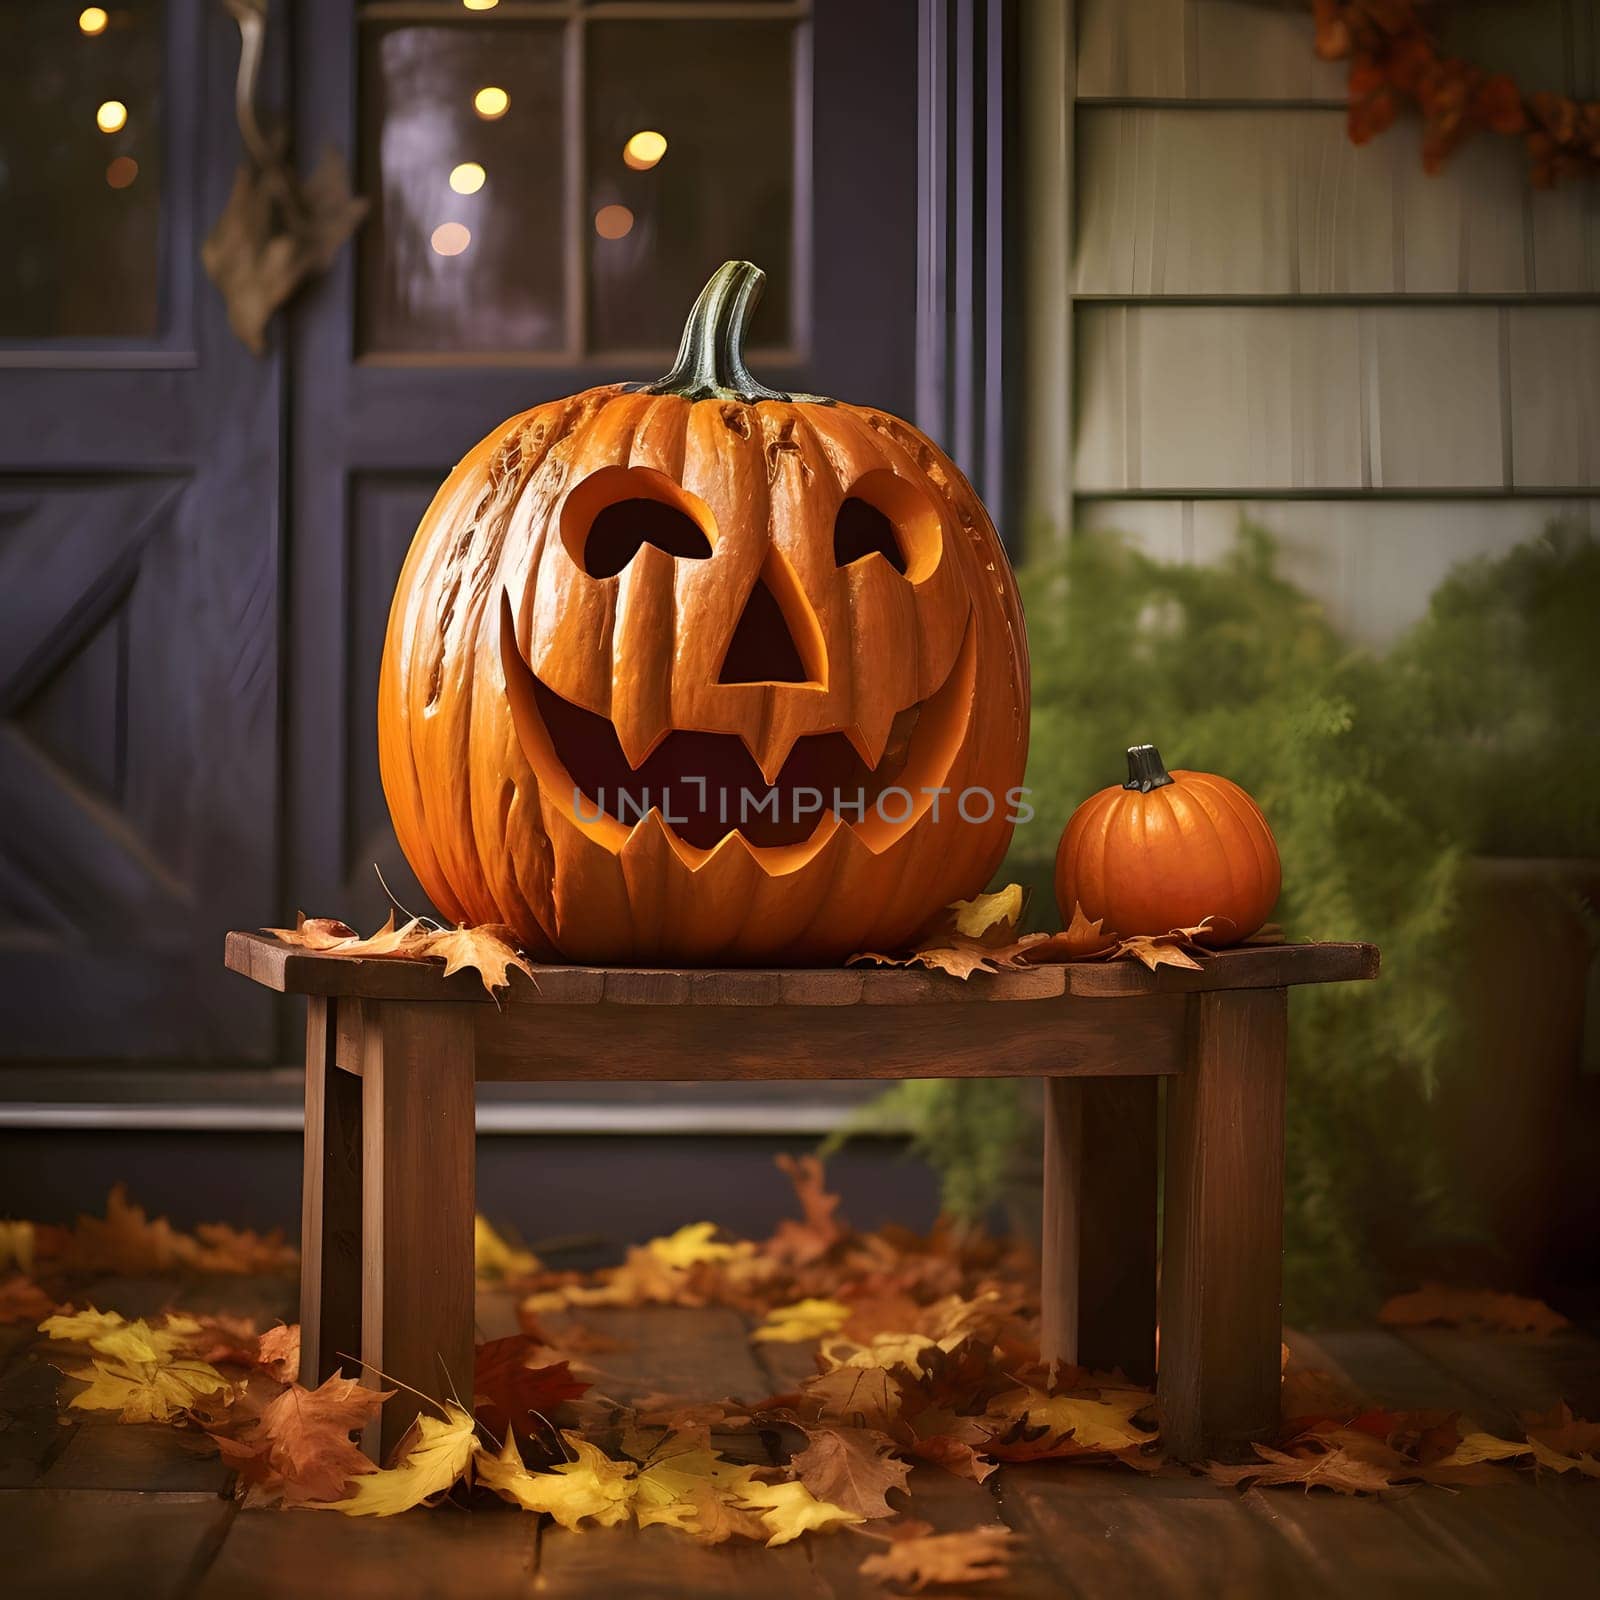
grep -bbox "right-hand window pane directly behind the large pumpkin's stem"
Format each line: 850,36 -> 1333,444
586,19 -> 795,350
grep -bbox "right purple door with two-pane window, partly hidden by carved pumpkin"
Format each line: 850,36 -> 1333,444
285,0 -> 918,926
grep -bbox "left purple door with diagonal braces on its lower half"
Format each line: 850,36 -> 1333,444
0,0 -> 282,1061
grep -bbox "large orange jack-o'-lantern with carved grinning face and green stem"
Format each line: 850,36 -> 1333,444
378,262 -> 1027,965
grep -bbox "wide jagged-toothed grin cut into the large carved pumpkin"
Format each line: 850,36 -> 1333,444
501,597 -> 976,867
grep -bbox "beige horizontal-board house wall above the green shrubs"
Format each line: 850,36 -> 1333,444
1024,0 -> 1600,643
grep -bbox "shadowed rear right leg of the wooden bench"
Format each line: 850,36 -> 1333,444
1040,1077 -> 1157,1382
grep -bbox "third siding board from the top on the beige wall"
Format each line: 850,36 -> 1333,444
1075,302 -> 1600,496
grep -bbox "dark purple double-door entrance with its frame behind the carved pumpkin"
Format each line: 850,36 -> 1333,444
0,0 -> 1014,1216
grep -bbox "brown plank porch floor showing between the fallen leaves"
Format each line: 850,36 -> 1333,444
0,1278 -> 1600,1600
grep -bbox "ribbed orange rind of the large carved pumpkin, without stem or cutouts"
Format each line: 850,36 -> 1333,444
379,267 -> 1026,962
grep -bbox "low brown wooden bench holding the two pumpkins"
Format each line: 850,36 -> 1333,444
227,933 -> 1378,1459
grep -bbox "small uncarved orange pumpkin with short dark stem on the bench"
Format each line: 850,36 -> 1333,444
1056,744 -> 1282,944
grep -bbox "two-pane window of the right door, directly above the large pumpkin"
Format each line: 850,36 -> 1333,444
357,0 -> 808,363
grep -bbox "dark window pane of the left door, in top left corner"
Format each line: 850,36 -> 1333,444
0,0 -> 163,339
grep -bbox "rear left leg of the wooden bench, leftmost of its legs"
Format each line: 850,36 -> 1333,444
299,995 -> 362,1389
